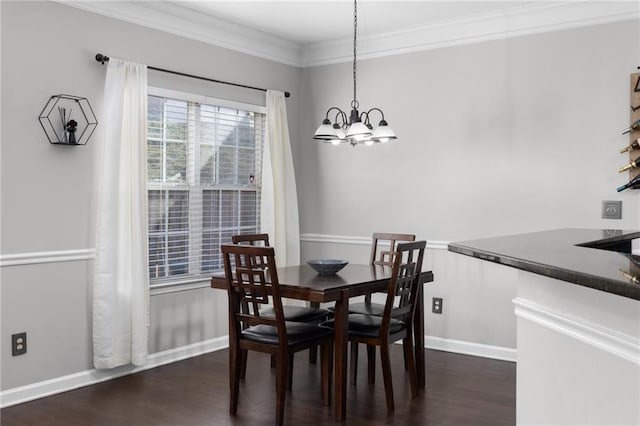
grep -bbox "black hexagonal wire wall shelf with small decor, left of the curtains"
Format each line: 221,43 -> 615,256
39,95 -> 98,145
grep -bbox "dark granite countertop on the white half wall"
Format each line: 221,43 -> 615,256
449,229 -> 640,300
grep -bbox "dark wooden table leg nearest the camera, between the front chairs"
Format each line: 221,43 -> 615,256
334,290 -> 349,422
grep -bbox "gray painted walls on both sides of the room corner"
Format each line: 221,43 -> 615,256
0,1 -> 640,396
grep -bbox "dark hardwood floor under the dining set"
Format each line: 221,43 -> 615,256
0,345 -> 516,426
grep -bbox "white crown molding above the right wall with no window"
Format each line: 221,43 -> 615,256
301,1 -> 640,67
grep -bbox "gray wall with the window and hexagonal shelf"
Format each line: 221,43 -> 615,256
0,1 -> 300,390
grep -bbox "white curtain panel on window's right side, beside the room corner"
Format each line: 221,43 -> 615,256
260,90 -> 300,266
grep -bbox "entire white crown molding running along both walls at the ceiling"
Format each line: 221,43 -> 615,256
53,0 -> 640,67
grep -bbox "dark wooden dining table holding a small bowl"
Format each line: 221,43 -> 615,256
211,263 -> 433,422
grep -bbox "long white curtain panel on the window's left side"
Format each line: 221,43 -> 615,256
93,58 -> 149,368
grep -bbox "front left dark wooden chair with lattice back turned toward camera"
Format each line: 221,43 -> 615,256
221,244 -> 334,425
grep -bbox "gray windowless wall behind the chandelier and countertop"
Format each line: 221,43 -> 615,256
298,20 -> 640,348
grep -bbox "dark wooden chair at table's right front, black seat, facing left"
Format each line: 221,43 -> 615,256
323,241 -> 426,413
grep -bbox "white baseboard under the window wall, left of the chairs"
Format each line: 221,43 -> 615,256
0,336 -> 229,408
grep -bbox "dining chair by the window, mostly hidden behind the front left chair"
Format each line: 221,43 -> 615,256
231,234 -> 333,370
